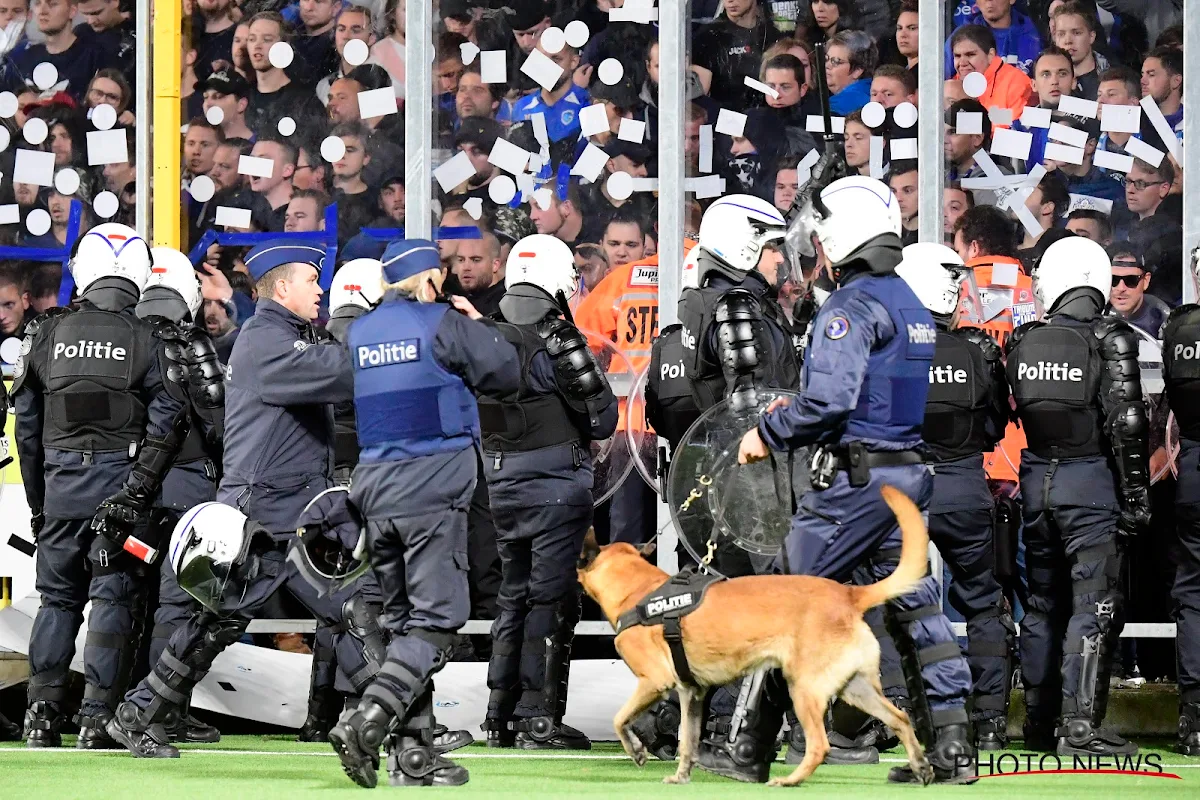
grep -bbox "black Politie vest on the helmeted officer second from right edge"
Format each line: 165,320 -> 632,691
1006,318 -> 1104,458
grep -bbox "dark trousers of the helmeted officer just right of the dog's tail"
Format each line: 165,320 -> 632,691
929,455 -> 1016,720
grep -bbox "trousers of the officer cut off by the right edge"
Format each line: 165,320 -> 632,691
1171,439 -> 1200,703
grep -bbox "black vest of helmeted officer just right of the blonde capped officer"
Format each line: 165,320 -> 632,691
479,323 -> 583,452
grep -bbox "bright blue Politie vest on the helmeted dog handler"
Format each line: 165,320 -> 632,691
835,275 -> 937,441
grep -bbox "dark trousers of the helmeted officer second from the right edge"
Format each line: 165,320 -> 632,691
1020,450 -> 1128,726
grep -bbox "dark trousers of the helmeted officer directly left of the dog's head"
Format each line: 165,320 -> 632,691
484,445 -> 593,717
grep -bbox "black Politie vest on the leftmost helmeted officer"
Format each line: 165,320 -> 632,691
42,308 -> 154,453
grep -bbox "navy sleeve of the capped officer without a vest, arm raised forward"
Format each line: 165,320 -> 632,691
254,327 -> 354,405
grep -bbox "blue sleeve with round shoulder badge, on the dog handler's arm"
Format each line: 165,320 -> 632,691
758,293 -> 895,450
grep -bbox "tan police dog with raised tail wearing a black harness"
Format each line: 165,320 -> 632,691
578,486 -> 934,786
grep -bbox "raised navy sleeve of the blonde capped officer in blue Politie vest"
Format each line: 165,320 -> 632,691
433,311 -> 521,397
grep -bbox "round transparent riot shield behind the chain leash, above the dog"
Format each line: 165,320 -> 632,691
667,389 -> 810,577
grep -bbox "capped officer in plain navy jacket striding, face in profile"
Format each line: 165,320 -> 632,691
107,240 -> 379,758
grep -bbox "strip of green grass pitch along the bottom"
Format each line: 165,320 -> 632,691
0,736 -> 1200,800
